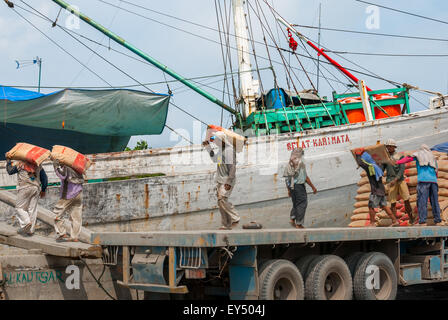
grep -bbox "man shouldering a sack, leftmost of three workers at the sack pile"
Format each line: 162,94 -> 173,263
355,148 -> 400,227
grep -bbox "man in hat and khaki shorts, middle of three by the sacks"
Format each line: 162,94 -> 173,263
383,139 -> 414,224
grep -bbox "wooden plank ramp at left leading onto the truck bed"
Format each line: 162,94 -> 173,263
0,222 -> 102,258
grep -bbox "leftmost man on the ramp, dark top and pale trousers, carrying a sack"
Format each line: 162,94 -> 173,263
6,159 -> 48,236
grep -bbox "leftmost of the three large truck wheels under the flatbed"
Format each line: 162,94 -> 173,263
258,259 -> 304,300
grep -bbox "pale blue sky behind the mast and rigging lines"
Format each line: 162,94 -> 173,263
0,0 -> 448,147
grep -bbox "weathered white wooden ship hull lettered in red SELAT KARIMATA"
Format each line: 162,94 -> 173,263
0,108 -> 448,231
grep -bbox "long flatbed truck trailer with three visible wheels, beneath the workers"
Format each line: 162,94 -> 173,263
91,226 -> 448,300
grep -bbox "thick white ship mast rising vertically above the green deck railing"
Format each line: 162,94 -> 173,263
232,0 -> 259,119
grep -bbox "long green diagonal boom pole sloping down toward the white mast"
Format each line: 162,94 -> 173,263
52,0 -> 241,119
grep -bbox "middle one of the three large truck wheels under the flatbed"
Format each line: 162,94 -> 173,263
305,255 -> 353,300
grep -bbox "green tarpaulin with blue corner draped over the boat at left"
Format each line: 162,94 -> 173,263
0,87 -> 170,136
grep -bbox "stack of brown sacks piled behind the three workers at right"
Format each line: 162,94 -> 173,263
349,151 -> 448,227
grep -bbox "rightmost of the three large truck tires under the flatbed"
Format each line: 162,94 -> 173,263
353,252 -> 398,300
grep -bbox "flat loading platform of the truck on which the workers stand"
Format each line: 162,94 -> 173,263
91,226 -> 448,247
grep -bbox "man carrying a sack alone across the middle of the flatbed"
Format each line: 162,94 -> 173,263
202,131 -> 240,230
